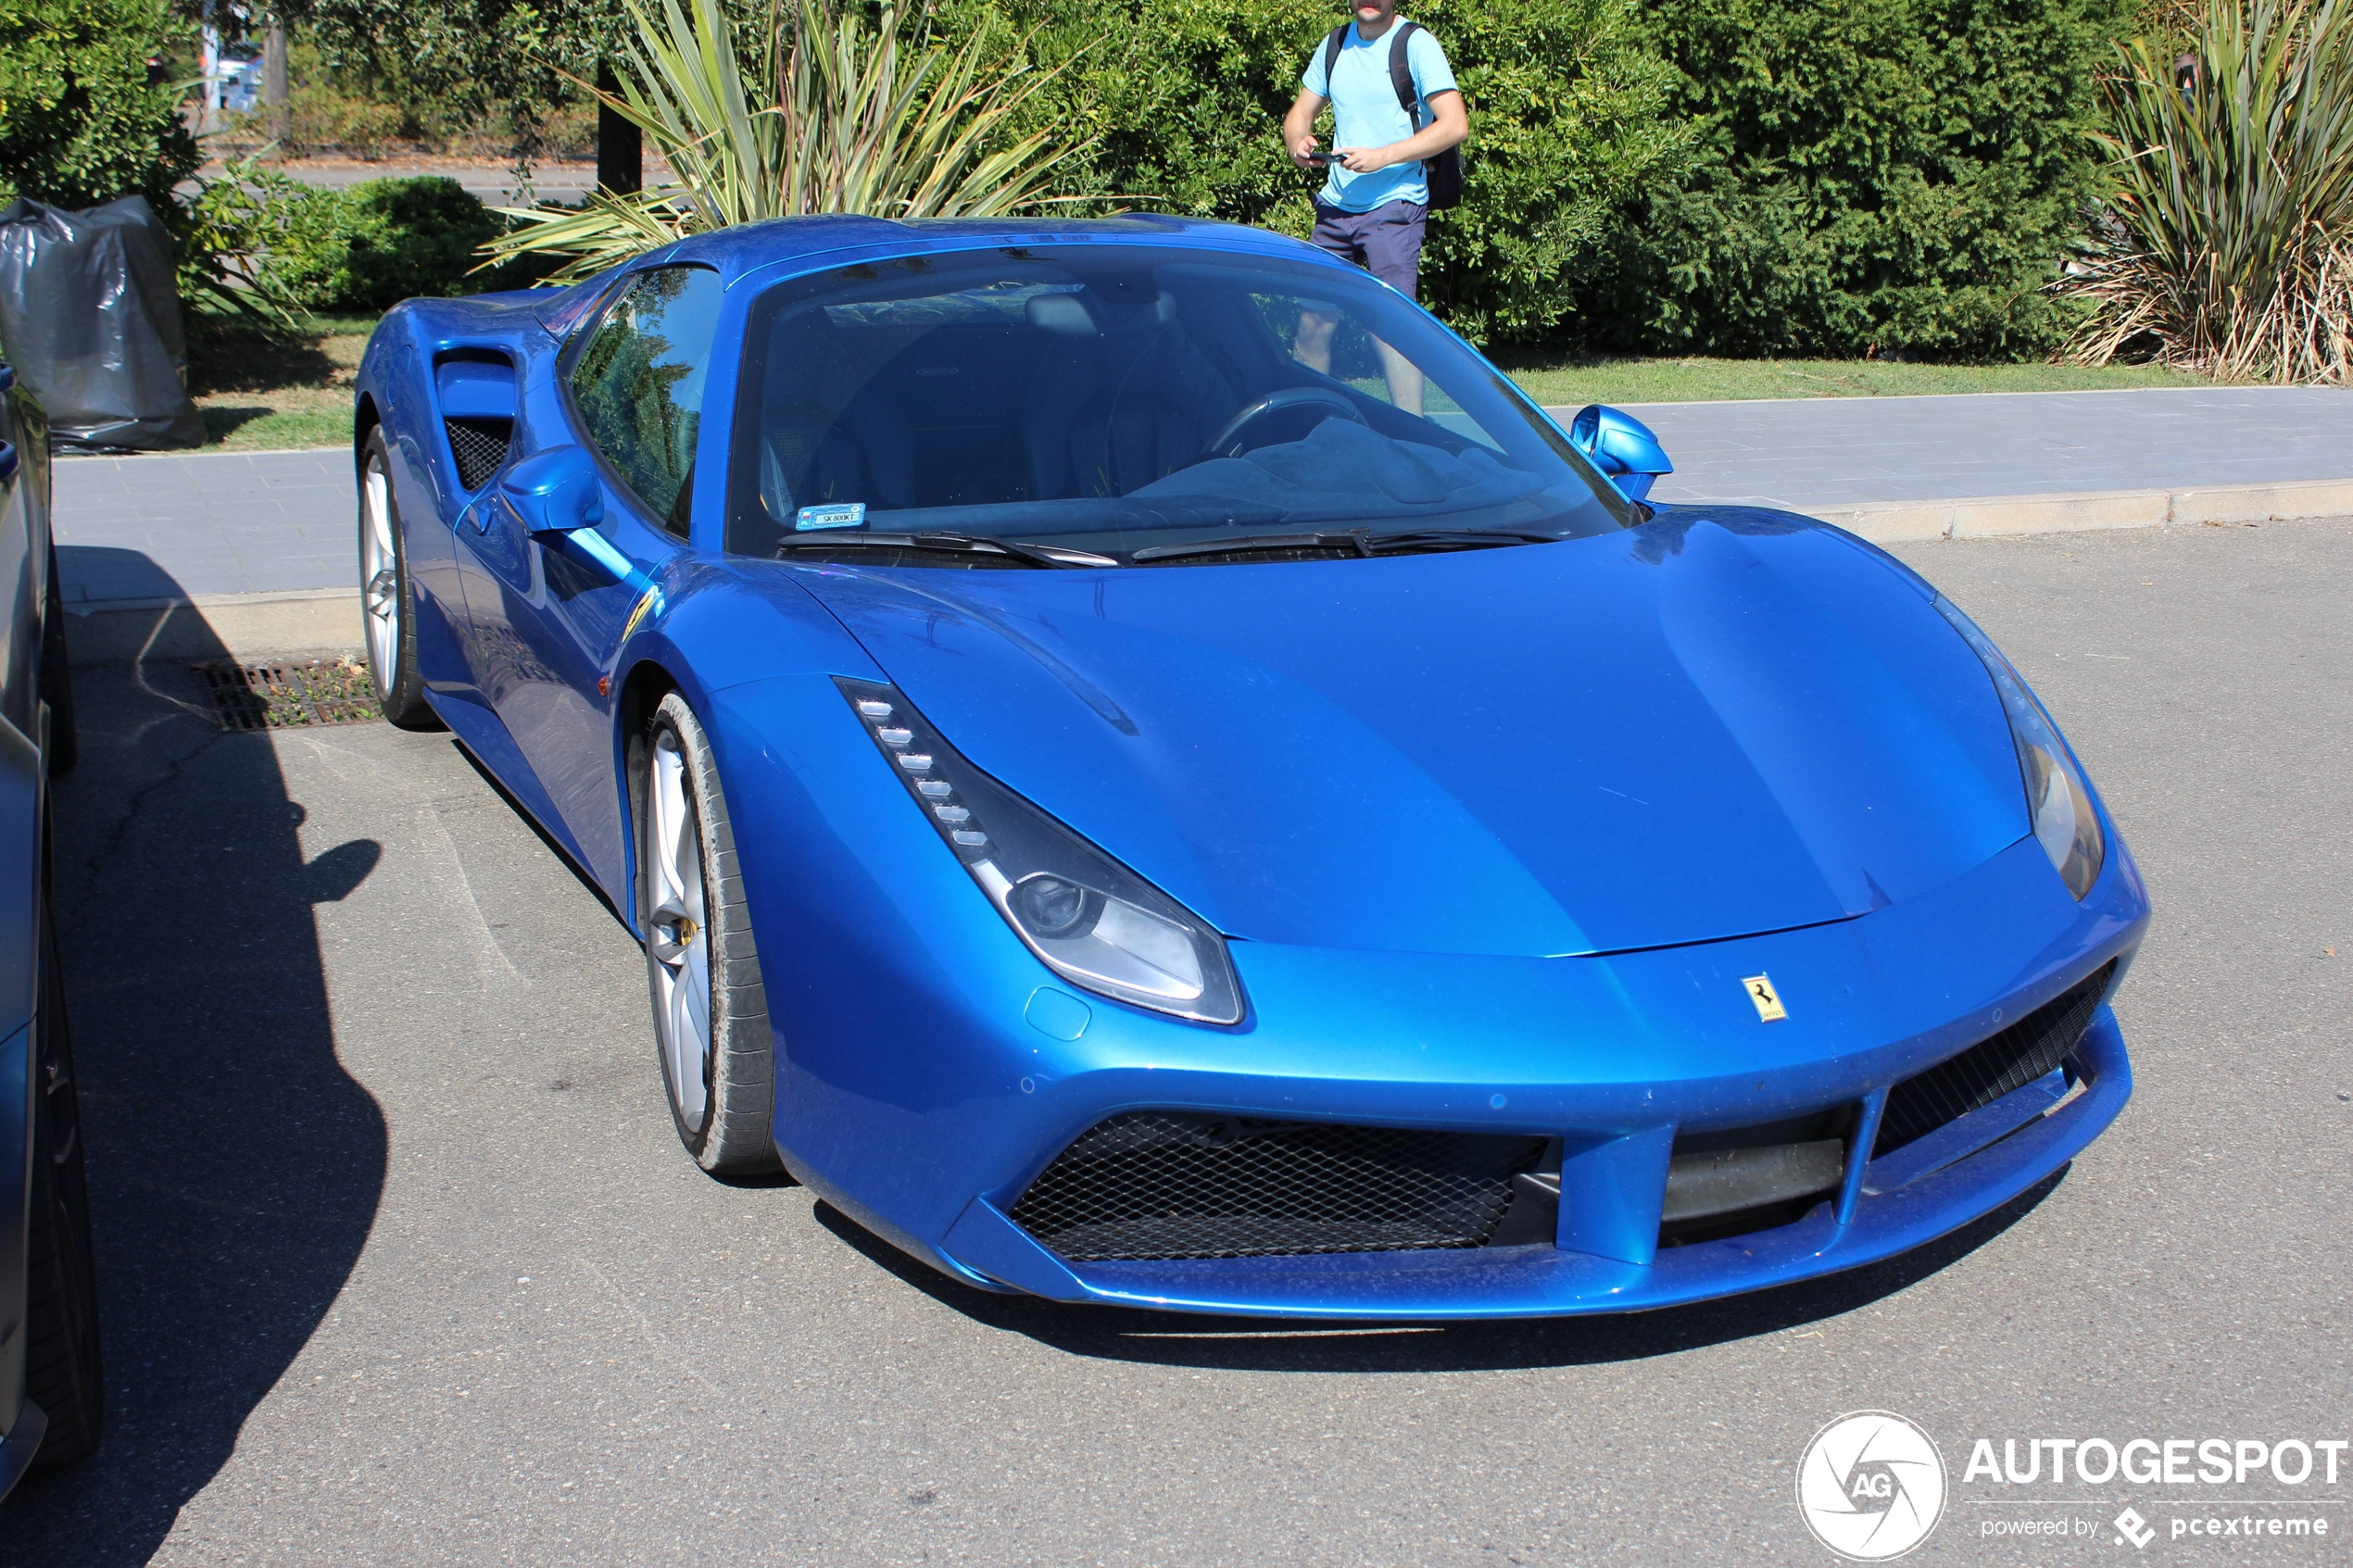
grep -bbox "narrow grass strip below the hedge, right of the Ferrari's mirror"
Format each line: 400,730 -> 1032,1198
1496,350 -> 2212,409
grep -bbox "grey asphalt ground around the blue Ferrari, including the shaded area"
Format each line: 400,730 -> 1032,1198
0,521 -> 2353,1568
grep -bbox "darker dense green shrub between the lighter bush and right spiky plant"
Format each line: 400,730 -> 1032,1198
1595,0 -> 2125,359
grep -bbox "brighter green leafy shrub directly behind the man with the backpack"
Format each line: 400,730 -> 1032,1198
941,0 -> 1692,344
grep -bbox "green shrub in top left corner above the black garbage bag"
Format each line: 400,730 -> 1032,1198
0,0 -> 202,210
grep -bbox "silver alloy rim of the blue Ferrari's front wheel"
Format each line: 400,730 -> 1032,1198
645,729 -> 711,1131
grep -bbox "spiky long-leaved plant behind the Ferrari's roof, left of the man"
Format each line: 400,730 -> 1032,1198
484,0 -> 1087,282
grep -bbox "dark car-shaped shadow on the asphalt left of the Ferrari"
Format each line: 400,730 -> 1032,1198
0,566 -> 386,1565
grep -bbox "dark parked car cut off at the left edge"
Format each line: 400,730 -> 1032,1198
0,364 -> 101,1495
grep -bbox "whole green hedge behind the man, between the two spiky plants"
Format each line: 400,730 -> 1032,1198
944,0 -> 2130,359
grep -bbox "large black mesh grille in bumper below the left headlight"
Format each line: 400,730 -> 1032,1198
1012,1112 -> 1548,1262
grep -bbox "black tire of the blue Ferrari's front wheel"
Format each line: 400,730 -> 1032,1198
631,691 -> 781,1175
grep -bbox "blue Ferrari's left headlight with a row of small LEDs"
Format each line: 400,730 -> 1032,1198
833,677 -> 1242,1022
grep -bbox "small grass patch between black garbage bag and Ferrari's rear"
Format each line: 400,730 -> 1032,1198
188,315 -> 376,451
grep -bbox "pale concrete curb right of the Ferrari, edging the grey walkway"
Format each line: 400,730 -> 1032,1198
1788,480 -> 2353,546
